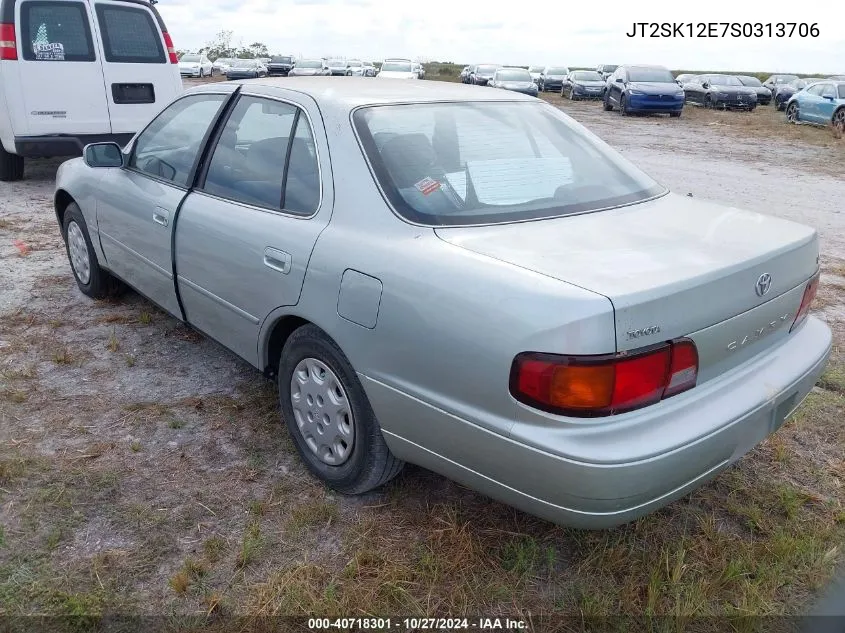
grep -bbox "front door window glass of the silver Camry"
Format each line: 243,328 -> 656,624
129,94 -> 227,187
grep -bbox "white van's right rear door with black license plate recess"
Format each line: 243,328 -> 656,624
93,0 -> 182,134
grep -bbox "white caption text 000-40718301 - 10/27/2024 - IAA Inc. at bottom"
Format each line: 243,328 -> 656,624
308,618 -> 529,631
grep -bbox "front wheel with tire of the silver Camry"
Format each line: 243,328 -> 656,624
62,202 -> 126,299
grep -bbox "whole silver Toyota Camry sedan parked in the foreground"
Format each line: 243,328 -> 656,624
55,77 -> 831,528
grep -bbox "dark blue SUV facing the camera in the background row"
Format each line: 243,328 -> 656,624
604,66 -> 684,117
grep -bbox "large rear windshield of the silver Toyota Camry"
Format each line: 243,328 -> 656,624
353,102 -> 665,226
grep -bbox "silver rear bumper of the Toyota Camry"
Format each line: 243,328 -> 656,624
370,317 -> 832,529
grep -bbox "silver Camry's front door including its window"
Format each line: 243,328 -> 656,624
97,93 -> 228,318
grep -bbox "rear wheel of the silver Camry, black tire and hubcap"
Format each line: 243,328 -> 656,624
278,325 -> 404,495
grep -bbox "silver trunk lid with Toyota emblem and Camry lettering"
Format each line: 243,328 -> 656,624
435,193 -> 818,379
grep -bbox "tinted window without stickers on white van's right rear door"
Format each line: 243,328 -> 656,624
96,4 -> 167,64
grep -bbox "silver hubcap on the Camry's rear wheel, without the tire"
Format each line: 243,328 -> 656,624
290,358 -> 355,466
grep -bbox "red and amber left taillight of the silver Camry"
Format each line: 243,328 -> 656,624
510,338 -> 698,417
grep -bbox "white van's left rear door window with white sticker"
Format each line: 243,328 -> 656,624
21,0 -> 96,62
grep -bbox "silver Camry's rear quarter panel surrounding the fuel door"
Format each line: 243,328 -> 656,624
274,103 -> 615,439
